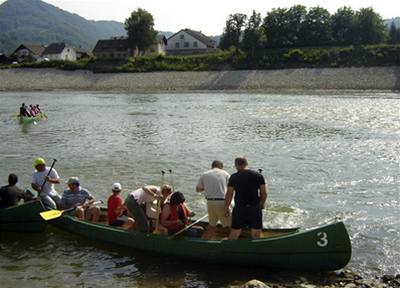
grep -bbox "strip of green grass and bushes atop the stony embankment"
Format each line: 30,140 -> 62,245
2,44 -> 400,73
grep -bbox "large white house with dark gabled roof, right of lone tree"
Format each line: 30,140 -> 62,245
167,28 -> 215,54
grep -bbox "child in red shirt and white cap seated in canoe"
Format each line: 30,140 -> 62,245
107,182 -> 135,230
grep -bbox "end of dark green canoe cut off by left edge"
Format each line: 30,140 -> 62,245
0,200 -> 46,232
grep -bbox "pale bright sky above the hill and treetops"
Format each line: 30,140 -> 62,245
0,0 -> 400,36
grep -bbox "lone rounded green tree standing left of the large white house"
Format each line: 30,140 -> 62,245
125,8 -> 157,55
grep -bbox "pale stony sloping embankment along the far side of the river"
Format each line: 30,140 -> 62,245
0,66 -> 400,92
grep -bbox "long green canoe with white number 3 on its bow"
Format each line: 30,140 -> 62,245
52,215 -> 351,271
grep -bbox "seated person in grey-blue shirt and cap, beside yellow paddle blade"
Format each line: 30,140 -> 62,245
61,177 -> 100,222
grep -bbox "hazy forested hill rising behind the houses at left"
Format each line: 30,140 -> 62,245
0,0 -> 126,54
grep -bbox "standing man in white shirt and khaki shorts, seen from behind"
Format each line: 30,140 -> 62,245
196,160 -> 231,239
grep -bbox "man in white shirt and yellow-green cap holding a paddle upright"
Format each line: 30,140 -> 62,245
31,157 -> 61,209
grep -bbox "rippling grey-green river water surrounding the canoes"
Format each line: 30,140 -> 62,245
0,91 -> 400,287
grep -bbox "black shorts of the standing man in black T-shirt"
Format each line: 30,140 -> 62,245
231,204 -> 262,229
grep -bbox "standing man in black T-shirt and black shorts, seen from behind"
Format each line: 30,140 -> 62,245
224,157 -> 267,240
